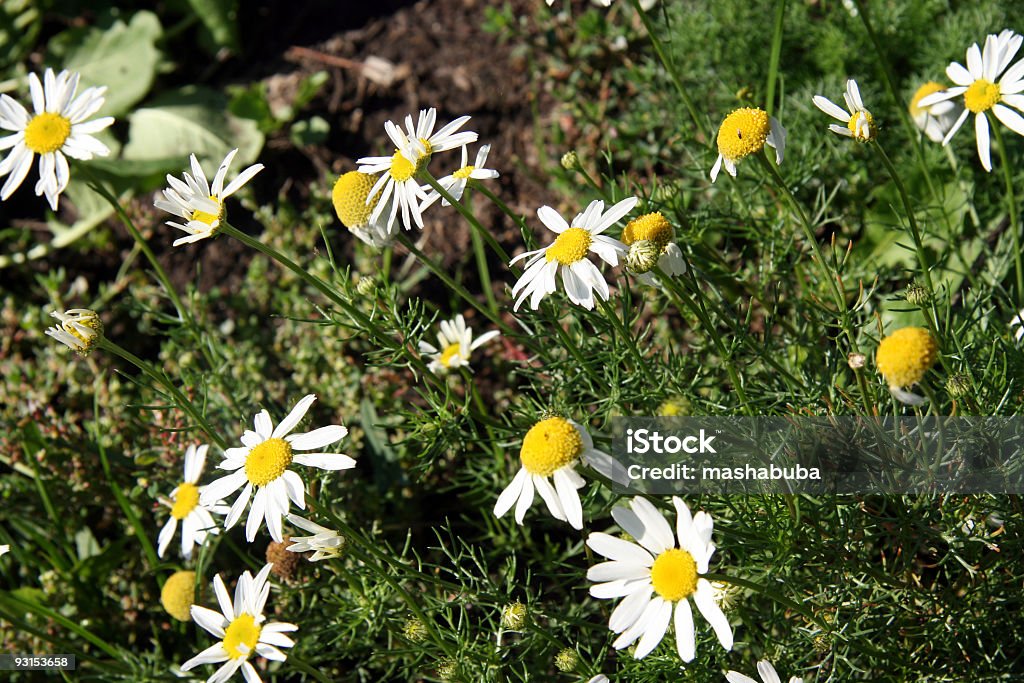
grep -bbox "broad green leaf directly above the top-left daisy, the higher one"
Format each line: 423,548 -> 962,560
50,11 -> 163,116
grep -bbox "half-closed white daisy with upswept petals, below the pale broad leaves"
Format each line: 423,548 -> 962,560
153,147 -> 263,247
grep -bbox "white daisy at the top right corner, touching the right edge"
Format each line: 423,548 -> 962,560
920,30 -> 1024,171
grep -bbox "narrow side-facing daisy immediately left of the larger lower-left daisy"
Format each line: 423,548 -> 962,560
157,443 -> 228,559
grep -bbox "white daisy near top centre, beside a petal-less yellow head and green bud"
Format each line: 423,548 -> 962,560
509,197 -> 638,310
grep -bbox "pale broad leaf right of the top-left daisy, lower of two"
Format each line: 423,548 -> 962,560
124,87 -> 263,169
